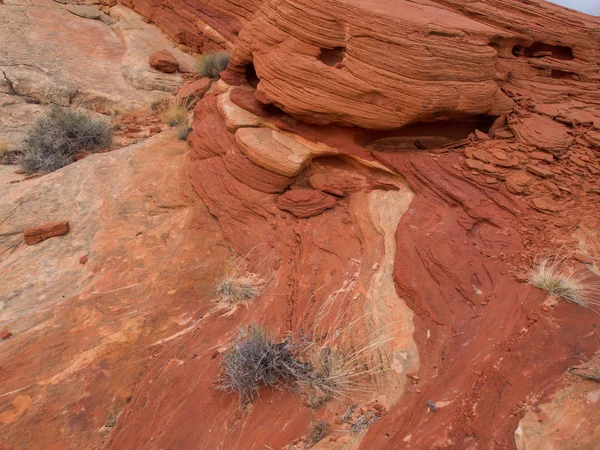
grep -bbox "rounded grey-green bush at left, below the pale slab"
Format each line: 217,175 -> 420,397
18,106 -> 112,173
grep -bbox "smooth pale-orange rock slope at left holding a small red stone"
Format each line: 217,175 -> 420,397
0,133 -> 228,449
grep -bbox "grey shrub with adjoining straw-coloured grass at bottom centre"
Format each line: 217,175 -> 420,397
219,272 -> 388,409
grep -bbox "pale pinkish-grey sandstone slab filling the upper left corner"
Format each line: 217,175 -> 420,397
0,0 -> 166,111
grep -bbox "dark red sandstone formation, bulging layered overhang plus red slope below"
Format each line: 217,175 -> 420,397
104,0 -> 600,449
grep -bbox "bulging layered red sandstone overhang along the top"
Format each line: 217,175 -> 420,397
225,0 -> 599,129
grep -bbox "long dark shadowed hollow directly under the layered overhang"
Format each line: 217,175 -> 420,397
360,115 -> 497,152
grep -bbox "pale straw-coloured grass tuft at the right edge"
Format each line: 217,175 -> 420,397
528,254 -> 600,308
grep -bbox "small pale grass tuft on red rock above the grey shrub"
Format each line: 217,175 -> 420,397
216,257 -> 264,304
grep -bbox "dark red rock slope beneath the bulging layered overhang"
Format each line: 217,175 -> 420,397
109,77 -> 600,449
